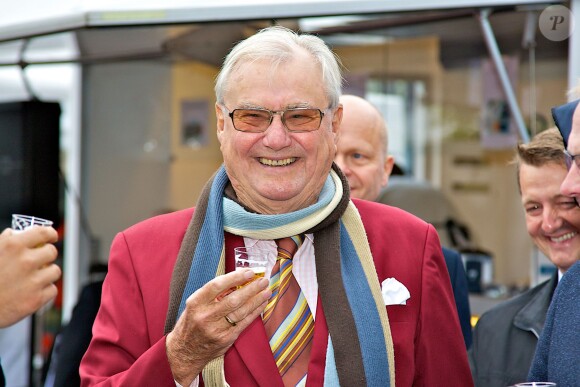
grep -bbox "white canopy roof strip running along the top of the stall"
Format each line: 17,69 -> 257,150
0,0 -> 568,41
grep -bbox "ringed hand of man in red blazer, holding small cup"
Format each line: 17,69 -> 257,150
166,270 -> 271,386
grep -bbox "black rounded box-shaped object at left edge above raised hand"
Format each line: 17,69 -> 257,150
0,101 -> 62,230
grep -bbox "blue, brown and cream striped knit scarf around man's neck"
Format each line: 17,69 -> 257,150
165,164 -> 395,386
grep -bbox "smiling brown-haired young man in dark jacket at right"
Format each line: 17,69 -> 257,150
469,128 -> 580,387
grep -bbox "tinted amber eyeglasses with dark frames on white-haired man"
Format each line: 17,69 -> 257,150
222,106 -> 324,133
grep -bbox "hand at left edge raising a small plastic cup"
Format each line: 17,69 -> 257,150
0,227 -> 61,328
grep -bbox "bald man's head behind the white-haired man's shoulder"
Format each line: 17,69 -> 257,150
335,95 -> 394,200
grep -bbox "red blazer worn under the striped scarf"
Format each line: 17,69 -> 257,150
80,200 -> 473,387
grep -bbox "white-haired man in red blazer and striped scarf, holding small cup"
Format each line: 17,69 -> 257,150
80,26 -> 472,387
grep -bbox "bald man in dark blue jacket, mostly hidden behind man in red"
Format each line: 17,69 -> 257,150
334,95 -> 472,348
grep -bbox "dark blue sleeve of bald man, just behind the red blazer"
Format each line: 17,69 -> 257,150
443,247 -> 472,349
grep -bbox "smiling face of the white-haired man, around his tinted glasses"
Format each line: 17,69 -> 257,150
216,51 -> 342,214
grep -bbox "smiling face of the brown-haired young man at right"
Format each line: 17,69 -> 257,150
520,163 -> 580,272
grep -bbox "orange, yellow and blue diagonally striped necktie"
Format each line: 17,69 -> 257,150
263,234 -> 314,386
